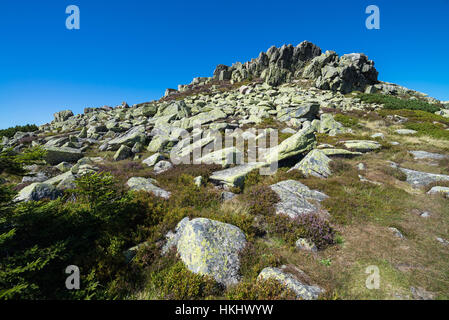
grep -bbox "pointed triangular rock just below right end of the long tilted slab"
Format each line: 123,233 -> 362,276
288,149 -> 332,178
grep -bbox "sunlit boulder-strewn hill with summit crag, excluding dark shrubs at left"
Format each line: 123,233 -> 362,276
1,41 -> 449,299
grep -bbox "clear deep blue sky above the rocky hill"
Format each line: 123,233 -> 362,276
0,0 -> 449,128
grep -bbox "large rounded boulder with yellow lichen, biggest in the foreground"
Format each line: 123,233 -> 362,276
176,218 -> 246,286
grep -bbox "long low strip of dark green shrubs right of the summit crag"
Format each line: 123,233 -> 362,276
358,93 -> 441,113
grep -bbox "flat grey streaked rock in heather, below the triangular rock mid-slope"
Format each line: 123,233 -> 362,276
270,180 -> 327,218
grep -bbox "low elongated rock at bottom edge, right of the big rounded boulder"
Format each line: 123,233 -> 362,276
257,267 -> 324,300
